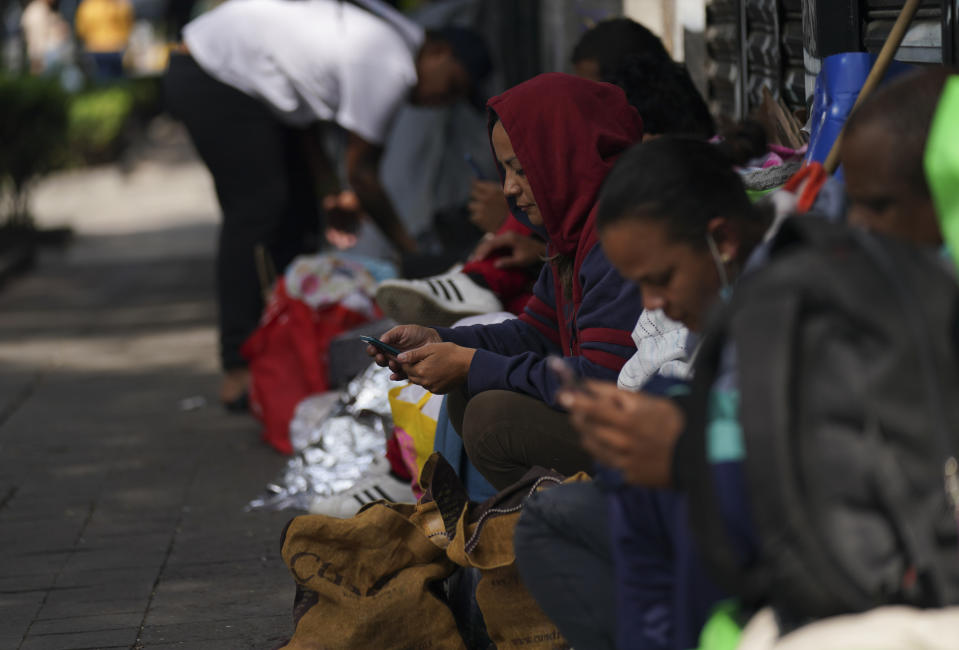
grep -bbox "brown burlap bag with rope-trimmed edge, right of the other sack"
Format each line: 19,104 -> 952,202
446,469 -> 586,650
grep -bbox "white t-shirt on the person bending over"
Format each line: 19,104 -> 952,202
183,0 -> 423,144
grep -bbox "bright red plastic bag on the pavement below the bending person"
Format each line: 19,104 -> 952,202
240,278 -> 370,454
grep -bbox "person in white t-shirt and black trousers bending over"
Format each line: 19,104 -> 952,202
165,0 -> 491,409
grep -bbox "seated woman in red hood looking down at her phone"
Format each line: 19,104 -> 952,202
368,73 -> 642,489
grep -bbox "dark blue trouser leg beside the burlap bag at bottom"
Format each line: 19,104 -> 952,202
514,482 -> 616,650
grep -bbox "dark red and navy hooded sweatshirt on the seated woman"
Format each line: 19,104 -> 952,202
438,73 -> 643,405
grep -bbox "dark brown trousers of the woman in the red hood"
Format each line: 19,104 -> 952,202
447,390 -> 593,490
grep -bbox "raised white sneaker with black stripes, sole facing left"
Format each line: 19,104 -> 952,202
376,270 -> 503,327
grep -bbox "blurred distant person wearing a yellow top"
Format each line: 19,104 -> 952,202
76,0 -> 133,81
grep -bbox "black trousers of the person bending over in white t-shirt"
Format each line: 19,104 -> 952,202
164,54 -> 320,369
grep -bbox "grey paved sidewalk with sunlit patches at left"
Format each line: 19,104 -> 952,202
0,125 -> 294,650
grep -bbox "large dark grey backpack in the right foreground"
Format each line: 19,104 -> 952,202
681,217 -> 959,620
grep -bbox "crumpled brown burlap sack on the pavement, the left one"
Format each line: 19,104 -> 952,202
282,503 -> 464,650
